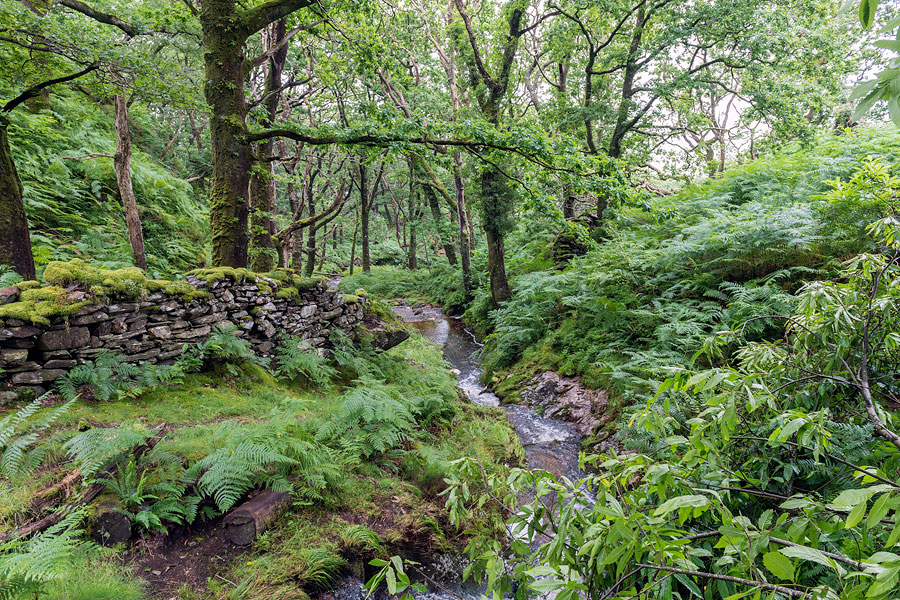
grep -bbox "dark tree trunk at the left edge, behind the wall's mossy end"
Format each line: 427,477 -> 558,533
0,114 -> 36,279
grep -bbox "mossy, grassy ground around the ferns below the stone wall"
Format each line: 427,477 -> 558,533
0,337 -> 523,600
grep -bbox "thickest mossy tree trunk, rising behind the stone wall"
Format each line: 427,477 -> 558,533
200,0 -> 314,267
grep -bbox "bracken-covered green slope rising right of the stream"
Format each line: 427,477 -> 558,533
474,129 -> 900,406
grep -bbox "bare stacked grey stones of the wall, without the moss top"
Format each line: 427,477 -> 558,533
0,275 -> 365,404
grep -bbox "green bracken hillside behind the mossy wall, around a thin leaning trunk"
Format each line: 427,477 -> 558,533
9,93 -> 209,278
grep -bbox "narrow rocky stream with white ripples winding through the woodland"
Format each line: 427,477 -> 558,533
329,303 -> 581,600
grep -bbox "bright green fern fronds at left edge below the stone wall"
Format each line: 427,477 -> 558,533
0,394 -> 72,477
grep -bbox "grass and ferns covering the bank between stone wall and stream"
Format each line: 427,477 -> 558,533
0,331 -> 523,600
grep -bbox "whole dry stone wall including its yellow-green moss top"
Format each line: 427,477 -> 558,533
0,261 -> 365,404
